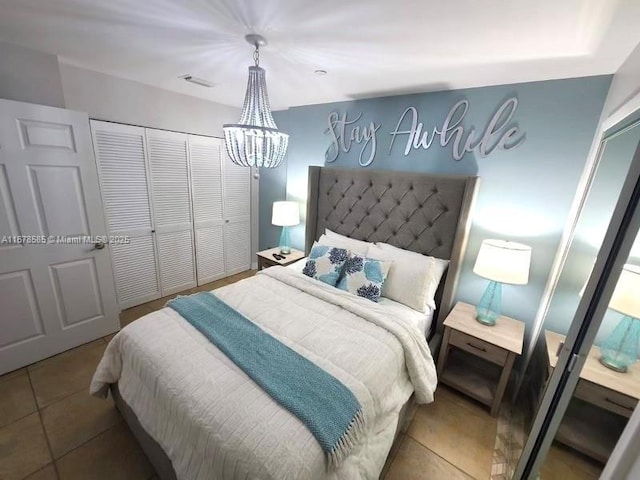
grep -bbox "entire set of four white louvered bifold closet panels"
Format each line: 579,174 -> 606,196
91,120 -> 251,309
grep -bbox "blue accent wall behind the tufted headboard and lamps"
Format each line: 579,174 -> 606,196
260,76 -> 611,334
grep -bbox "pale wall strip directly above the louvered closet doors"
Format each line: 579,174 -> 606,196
60,63 -> 242,137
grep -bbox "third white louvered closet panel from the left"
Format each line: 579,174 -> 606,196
189,135 -> 226,285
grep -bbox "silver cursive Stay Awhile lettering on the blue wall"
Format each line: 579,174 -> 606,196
325,97 -> 525,167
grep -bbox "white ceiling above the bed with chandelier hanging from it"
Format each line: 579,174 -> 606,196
0,0 -> 640,110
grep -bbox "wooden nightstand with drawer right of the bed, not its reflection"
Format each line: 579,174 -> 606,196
438,302 -> 524,417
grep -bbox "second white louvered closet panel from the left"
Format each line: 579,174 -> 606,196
145,128 -> 196,296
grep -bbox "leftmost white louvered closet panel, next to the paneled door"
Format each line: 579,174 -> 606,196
91,120 -> 161,309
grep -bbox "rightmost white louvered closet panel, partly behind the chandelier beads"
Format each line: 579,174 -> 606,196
223,152 -> 251,275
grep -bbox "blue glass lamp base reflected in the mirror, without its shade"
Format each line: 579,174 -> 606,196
600,315 -> 640,373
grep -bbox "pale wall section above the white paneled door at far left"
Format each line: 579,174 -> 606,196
0,42 -> 64,107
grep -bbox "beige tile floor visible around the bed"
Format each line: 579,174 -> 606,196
0,271 -> 600,480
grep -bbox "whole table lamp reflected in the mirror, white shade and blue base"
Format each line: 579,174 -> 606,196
600,264 -> 640,372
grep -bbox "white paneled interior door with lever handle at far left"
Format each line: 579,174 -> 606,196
0,100 -> 119,374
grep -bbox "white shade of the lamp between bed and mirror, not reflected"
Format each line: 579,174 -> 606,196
473,240 -> 531,285
